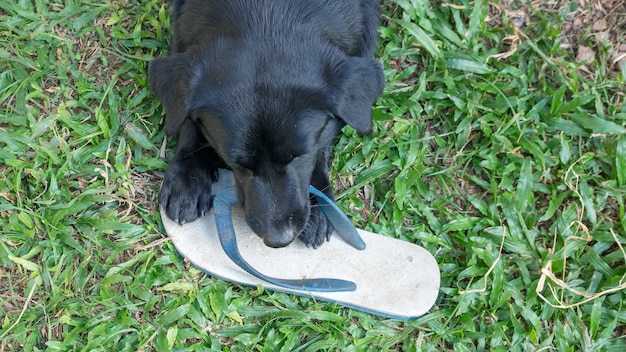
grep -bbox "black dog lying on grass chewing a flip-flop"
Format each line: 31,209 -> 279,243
149,0 -> 384,248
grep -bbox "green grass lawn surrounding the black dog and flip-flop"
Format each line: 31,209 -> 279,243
0,0 -> 626,351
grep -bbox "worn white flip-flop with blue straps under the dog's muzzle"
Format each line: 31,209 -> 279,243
161,170 -> 440,320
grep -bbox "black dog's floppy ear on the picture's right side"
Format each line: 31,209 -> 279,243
330,57 -> 385,134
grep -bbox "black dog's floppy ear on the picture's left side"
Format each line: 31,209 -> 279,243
148,54 -> 191,135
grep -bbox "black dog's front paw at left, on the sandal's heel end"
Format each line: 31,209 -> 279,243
159,161 -> 216,225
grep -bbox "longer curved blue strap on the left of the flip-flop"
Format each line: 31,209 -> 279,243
213,184 -> 356,292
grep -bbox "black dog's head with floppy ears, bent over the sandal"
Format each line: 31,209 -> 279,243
149,47 -> 384,247
